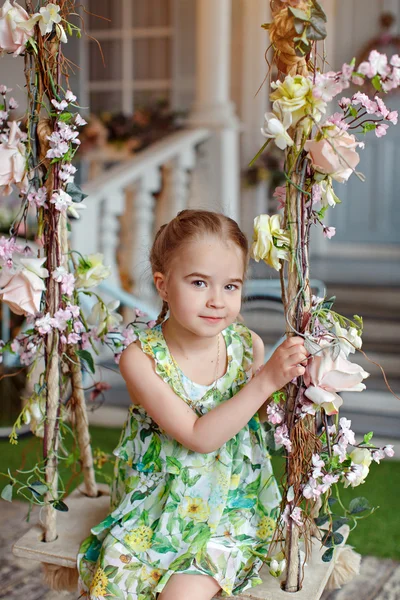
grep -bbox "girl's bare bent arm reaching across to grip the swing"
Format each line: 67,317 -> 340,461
120,337 -> 307,454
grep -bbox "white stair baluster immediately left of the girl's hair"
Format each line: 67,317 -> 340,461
130,168 -> 161,301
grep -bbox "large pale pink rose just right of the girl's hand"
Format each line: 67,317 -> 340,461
304,342 -> 369,415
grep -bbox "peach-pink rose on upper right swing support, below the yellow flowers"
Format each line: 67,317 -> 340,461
304,126 -> 360,183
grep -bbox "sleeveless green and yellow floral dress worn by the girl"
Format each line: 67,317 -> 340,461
78,323 -> 280,600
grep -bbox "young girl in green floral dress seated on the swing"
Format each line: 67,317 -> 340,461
78,210 -> 307,600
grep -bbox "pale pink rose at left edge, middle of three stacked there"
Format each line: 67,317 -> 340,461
0,121 -> 29,196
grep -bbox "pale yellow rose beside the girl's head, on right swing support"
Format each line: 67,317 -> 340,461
251,215 -> 290,271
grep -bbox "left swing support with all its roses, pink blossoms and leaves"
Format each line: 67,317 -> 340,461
0,0 -> 153,541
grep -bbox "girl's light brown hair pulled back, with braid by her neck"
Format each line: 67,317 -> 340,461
150,209 -> 249,324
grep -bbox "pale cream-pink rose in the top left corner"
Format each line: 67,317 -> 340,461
0,0 -> 33,56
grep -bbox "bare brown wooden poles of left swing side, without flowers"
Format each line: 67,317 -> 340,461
34,4 -> 98,542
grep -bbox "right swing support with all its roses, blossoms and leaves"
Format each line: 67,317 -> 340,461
252,0 -> 400,591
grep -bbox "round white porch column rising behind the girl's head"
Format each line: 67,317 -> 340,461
189,0 -> 240,219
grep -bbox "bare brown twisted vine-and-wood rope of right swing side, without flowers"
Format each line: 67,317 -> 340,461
269,0 -> 318,592
